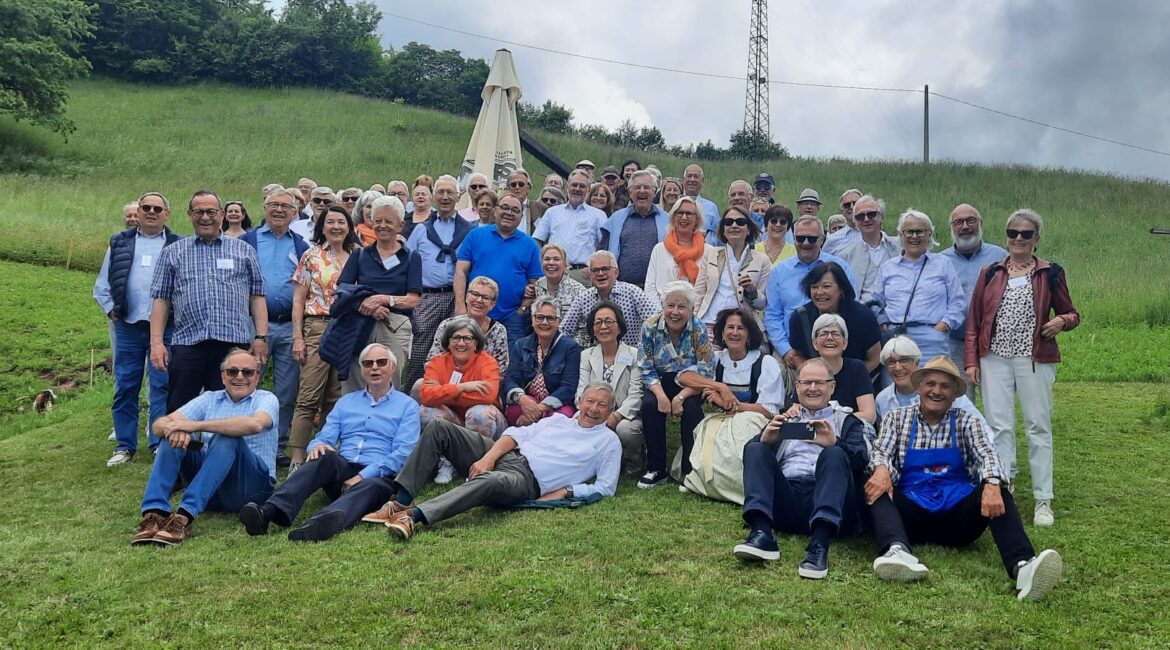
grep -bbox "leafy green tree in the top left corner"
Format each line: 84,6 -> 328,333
0,0 -> 90,136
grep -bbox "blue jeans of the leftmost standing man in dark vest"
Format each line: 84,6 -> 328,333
111,320 -> 171,452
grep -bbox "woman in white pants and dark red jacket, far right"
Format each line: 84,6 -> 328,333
964,209 -> 1081,526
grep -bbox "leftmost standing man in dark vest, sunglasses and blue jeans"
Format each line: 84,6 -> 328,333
94,192 -> 179,468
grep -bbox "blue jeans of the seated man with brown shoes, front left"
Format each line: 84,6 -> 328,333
143,436 -> 276,517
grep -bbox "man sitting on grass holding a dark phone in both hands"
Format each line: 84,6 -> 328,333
734,359 -> 869,580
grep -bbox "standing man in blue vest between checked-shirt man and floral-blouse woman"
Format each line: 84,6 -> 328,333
240,188 -> 319,468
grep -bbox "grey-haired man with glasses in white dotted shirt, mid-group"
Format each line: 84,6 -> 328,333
560,250 -> 662,350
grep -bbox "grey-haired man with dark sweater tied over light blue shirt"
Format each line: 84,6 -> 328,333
404,174 -> 472,387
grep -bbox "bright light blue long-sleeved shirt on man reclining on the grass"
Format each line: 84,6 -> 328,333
308,389 -> 419,479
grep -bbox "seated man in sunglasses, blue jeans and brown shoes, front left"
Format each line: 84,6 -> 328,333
130,348 -> 280,546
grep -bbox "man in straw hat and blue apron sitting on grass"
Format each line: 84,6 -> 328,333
866,355 -> 1064,601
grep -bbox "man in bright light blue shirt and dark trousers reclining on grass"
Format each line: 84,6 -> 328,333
240,343 -> 419,541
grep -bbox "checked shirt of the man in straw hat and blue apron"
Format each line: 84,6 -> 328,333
872,403 -> 1007,485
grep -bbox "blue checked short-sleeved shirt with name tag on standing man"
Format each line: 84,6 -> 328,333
151,235 -> 264,345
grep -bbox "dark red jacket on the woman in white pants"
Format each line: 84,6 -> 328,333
963,257 -> 1081,368
